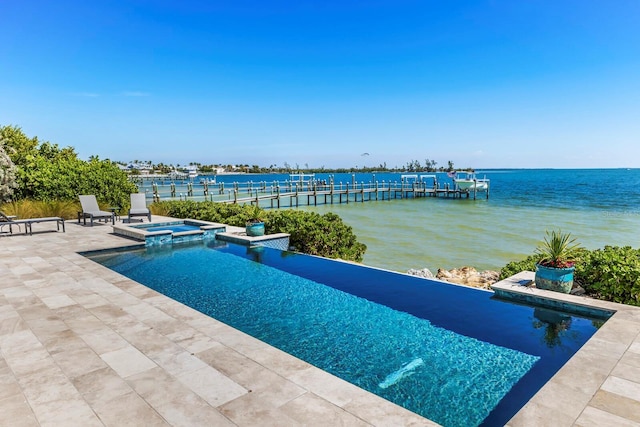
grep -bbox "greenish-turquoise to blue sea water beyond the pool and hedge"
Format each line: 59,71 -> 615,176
142,169 -> 640,272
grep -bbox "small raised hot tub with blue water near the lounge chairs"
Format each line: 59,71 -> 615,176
113,219 -> 226,246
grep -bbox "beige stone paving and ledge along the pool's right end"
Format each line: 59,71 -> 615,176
492,271 -> 640,427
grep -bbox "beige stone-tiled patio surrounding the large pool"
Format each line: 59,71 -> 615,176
0,217 -> 640,427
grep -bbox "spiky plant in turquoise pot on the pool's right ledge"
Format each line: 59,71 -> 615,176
535,230 -> 581,293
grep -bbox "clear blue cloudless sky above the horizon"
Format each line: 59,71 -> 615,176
0,0 -> 640,168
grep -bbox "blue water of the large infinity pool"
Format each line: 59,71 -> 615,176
89,241 -> 602,426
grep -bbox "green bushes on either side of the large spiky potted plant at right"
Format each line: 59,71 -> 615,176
500,246 -> 640,306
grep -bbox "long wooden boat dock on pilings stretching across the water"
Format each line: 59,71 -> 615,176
141,175 -> 489,208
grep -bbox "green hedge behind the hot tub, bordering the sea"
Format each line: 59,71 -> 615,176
151,201 -> 367,262
